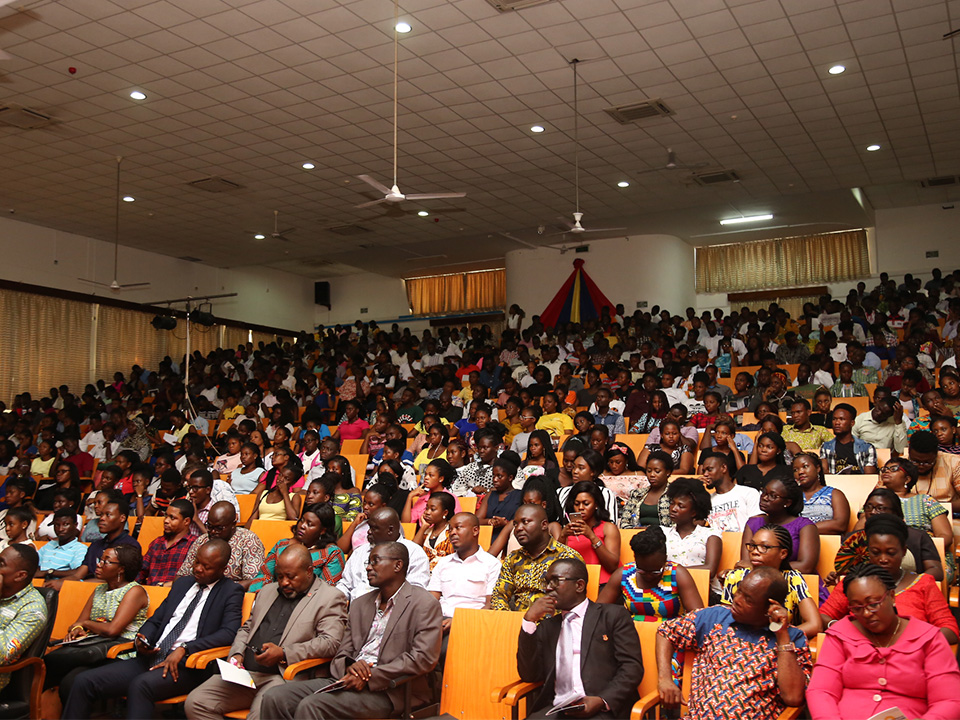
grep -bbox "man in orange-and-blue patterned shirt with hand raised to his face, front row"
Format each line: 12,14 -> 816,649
657,567 -> 813,718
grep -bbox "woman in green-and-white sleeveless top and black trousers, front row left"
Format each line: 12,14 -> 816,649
43,545 -> 150,703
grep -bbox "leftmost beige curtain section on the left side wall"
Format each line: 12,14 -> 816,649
0,290 -> 93,405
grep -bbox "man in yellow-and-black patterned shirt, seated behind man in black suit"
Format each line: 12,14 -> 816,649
490,505 -> 581,612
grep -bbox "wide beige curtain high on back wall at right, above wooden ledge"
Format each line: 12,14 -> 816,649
697,230 -> 870,293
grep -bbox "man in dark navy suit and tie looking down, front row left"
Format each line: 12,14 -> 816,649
61,540 -> 243,720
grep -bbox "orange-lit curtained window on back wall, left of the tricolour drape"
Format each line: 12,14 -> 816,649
403,268 -> 507,315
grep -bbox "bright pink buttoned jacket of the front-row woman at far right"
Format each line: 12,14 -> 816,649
807,617 -> 960,720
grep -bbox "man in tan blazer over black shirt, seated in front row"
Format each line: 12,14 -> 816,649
186,545 -> 347,720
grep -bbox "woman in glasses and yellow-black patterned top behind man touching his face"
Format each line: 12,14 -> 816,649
720,525 -> 823,638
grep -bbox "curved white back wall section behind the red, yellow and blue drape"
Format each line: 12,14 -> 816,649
506,235 -> 696,318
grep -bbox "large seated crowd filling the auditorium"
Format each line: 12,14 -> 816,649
0,270 -> 960,720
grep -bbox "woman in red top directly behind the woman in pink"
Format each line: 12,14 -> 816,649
820,515 -> 960,644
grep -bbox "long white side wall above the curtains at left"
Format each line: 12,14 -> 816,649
0,218 -> 316,330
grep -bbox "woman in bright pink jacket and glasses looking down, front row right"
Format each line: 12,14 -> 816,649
806,564 -> 960,720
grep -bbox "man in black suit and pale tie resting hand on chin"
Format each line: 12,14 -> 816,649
517,559 -> 643,718
